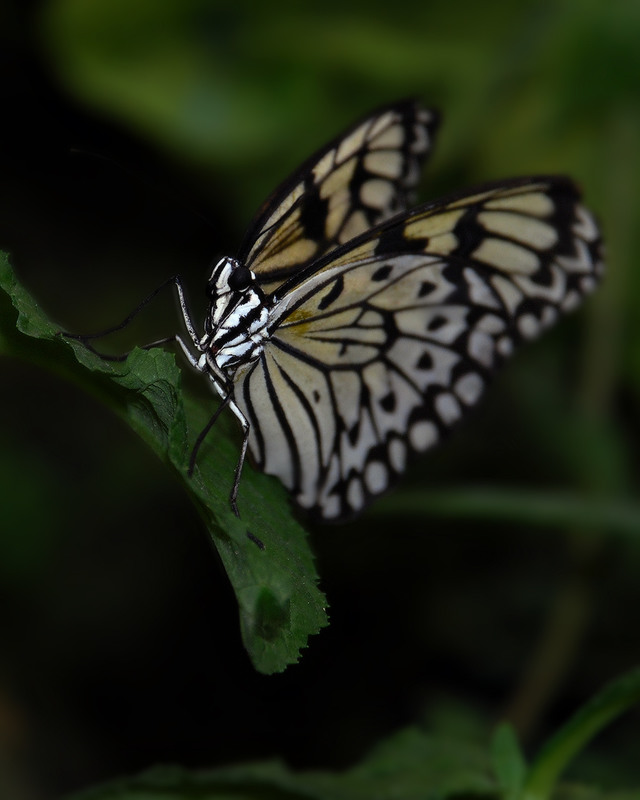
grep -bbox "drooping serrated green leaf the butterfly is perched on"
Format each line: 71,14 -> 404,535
0,256 -> 327,673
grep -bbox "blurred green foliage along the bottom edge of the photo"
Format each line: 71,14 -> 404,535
56,670 -> 640,800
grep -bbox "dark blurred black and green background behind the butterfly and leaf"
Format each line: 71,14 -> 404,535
0,0 -> 640,800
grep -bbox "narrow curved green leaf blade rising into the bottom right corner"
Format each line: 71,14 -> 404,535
521,669 -> 640,800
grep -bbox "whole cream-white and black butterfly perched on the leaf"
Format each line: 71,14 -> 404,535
86,101 -> 603,520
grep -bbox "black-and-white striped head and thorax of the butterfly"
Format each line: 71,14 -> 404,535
201,258 -> 270,375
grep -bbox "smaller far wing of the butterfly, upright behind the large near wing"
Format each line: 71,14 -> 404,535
238,101 -> 438,293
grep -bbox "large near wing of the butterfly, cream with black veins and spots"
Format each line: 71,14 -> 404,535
234,178 -> 603,520
